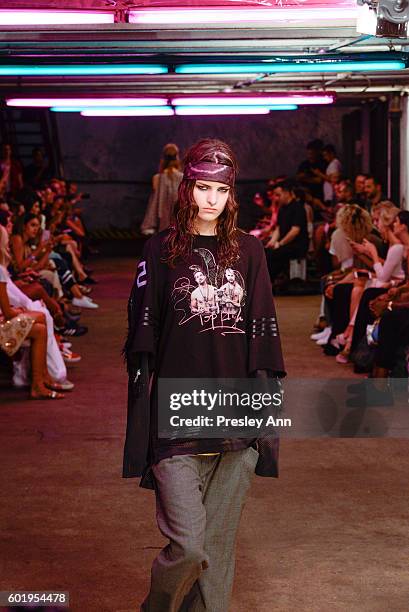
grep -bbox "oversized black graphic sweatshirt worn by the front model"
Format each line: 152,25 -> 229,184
124,230 -> 285,488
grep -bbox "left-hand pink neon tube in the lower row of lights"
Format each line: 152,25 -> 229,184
6,97 -> 168,108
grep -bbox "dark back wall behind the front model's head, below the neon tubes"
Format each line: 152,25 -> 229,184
57,107 -> 351,229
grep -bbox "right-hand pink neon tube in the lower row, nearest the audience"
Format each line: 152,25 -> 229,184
172,93 -> 334,106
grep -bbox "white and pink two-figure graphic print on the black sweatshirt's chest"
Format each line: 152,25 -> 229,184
172,248 -> 246,336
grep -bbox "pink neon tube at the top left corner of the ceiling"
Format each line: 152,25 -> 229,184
0,10 -> 115,26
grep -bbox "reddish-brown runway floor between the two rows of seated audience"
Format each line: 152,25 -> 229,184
0,259 -> 409,612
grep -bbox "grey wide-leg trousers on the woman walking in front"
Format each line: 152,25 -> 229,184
141,447 -> 258,612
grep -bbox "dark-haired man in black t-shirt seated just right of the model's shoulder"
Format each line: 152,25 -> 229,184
266,179 -> 308,280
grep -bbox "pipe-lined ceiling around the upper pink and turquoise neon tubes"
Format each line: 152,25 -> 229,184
0,0 -> 409,103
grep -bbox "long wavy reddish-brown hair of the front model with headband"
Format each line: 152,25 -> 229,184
165,138 -> 239,267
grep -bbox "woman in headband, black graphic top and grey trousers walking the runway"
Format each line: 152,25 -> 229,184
123,139 -> 284,612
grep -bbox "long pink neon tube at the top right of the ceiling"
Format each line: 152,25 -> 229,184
128,5 -> 357,25
